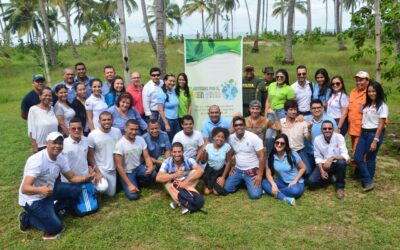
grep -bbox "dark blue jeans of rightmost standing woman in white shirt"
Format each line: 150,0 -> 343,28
354,131 -> 384,186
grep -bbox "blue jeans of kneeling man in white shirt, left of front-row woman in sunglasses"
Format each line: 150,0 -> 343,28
224,168 -> 262,199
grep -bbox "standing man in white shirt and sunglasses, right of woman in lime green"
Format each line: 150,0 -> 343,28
291,65 -> 313,116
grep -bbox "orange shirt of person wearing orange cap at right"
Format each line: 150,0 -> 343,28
347,88 -> 367,136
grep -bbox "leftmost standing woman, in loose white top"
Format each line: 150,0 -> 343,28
28,87 -> 58,153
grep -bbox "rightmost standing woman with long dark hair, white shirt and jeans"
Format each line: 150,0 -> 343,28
354,81 -> 389,191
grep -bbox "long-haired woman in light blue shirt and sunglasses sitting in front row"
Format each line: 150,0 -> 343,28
262,134 -> 306,206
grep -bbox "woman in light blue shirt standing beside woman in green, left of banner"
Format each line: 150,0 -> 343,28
157,74 -> 181,142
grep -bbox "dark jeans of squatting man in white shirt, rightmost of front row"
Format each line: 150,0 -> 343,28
308,160 -> 347,189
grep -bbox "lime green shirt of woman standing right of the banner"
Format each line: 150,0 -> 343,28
268,82 -> 295,110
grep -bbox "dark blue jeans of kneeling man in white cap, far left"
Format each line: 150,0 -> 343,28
22,182 -> 82,234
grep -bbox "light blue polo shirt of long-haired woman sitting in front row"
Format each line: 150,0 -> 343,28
274,151 -> 304,184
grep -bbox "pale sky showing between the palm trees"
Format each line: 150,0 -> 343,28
3,0 -> 351,41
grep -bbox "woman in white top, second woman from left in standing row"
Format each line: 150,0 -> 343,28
54,84 -> 75,137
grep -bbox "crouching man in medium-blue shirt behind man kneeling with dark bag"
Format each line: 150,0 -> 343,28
143,119 -> 171,169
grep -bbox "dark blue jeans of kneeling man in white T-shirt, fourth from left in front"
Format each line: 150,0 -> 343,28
121,165 -> 157,201
